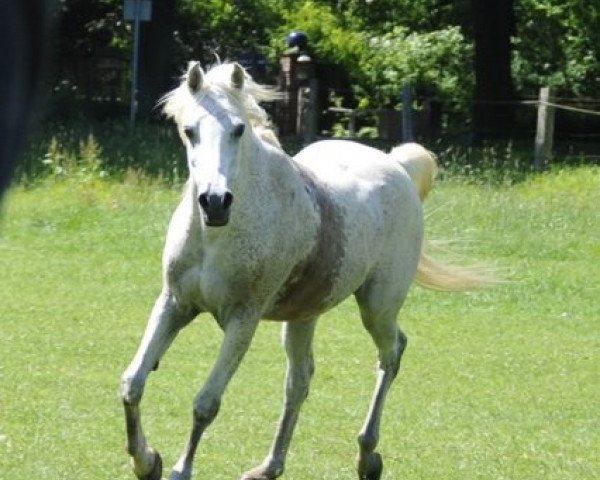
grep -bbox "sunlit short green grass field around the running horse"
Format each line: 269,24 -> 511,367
0,167 -> 600,480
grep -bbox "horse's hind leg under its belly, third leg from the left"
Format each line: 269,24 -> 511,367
242,319 -> 316,480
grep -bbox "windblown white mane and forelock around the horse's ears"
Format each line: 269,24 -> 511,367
159,62 -> 281,148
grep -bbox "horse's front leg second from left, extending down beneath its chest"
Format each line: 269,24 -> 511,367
169,315 -> 259,480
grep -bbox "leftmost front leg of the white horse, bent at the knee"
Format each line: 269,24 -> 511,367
121,293 -> 194,480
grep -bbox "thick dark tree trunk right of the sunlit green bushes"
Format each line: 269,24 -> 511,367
471,0 -> 514,139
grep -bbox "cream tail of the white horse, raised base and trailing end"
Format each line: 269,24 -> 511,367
389,143 -> 496,291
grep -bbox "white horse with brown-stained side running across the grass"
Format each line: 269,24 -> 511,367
121,63 -> 488,480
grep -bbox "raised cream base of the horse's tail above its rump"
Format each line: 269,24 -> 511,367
389,143 -> 438,201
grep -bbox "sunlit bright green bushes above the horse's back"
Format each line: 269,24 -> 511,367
273,1 -> 473,110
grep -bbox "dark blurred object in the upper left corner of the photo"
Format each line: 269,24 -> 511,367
0,0 -> 56,197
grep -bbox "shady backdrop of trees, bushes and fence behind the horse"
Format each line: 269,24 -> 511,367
8,0 -> 600,184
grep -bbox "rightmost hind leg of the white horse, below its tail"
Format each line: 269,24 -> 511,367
356,286 -> 407,480
